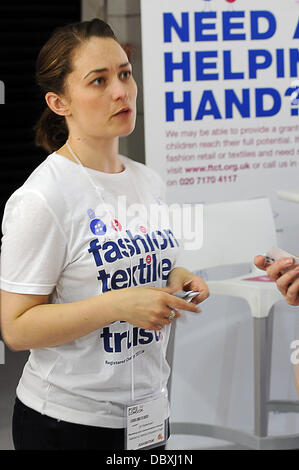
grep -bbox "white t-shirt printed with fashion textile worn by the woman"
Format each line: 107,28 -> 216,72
1,152 -> 179,428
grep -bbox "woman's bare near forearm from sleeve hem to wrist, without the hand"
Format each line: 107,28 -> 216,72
1,290 -> 120,350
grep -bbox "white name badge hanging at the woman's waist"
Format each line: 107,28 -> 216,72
125,395 -> 168,450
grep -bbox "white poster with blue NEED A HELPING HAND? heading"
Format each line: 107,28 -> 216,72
141,0 -> 299,215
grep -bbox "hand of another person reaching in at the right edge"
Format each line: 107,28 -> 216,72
254,255 -> 299,305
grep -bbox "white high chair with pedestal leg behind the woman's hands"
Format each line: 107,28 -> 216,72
167,198 -> 299,449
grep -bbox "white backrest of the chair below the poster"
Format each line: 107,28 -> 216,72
180,198 -> 277,271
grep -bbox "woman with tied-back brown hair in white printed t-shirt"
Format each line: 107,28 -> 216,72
1,19 -> 208,449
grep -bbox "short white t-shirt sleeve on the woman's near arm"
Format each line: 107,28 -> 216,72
0,190 -> 67,295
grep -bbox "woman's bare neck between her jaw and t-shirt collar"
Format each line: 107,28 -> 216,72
57,136 -> 124,173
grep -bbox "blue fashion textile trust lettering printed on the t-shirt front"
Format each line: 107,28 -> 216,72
88,207 -> 179,358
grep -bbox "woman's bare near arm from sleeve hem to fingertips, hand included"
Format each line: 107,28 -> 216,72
1,286 -> 202,351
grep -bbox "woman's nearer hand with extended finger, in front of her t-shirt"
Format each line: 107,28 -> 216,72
111,286 -> 199,330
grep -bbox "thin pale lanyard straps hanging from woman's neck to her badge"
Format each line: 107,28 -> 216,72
66,141 -> 170,403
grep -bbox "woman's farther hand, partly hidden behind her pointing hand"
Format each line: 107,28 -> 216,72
167,267 -> 210,310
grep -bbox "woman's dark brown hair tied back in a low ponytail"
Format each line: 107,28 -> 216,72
34,18 -> 118,152
